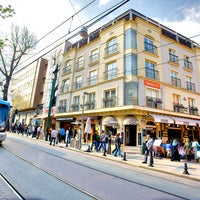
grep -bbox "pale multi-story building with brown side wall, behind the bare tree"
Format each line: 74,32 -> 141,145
11,58 -> 48,125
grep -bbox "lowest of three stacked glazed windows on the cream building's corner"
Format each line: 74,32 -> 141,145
124,82 -> 138,105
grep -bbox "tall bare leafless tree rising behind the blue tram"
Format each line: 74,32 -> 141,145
0,25 -> 37,101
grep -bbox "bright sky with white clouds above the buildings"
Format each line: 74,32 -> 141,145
0,0 -> 200,65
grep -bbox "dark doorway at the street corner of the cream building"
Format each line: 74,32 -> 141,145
125,125 -> 137,146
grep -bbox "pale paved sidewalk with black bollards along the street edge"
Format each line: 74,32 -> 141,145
8,133 -> 200,181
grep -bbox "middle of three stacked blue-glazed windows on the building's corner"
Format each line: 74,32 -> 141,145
125,53 -> 137,76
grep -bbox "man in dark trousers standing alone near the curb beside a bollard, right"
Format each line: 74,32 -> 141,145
143,134 -> 154,167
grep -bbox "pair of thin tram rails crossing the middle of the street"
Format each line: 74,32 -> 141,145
3,136 -> 192,199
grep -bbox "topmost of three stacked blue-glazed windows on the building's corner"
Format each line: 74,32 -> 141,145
124,29 -> 137,49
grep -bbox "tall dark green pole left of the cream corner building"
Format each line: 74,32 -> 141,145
45,64 -> 58,141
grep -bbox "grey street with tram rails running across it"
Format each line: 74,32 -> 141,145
0,134 -> 199,200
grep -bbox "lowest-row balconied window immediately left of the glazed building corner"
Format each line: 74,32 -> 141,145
104,89 -> 116,108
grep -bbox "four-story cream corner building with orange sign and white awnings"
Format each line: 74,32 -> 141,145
55,10 -> 200,147
